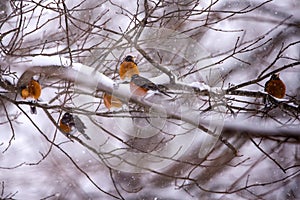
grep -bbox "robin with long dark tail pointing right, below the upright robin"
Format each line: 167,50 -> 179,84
130,74 -> 172,98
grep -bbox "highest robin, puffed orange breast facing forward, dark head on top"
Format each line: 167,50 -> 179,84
119,55 -> 140,81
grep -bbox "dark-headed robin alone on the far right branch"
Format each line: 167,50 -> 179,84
265,74 -> 286,99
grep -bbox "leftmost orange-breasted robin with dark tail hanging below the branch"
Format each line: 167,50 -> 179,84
21,78 -> 42,114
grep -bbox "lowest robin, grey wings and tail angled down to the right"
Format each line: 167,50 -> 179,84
59,112 -> 91,140
